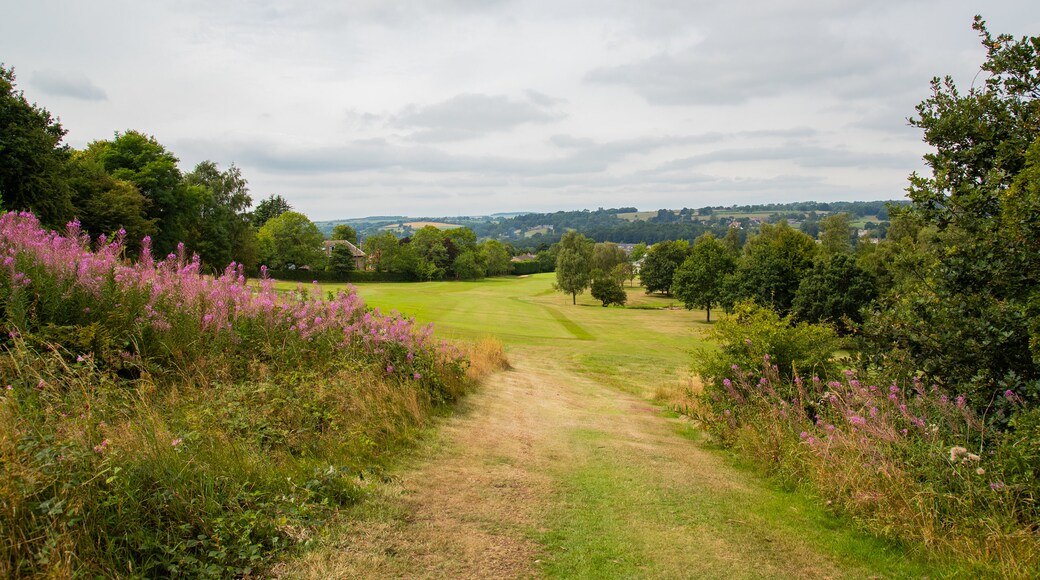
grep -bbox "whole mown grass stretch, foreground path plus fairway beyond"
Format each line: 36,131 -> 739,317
280,274 -> 948,578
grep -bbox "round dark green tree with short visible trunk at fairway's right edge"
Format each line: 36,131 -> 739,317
672,233 -> 736,322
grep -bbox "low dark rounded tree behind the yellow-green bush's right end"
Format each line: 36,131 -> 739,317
791,254 -> 878,333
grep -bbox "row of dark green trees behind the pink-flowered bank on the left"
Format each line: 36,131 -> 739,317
0,64 -> 332,269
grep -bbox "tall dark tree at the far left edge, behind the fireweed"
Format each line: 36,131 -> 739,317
0,63 -> 73,229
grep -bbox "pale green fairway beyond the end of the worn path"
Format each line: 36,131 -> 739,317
279,273 -> 708,395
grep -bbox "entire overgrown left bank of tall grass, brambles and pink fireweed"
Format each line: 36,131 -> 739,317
0,213 -> 473,577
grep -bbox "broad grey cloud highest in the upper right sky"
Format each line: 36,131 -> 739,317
584,4 -> 900,105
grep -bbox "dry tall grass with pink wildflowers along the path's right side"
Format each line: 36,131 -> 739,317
694,345 -> 1040,577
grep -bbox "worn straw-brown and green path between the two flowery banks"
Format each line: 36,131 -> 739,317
289,350 -> 919,578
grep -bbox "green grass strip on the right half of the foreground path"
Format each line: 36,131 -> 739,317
535,429 -> 958,578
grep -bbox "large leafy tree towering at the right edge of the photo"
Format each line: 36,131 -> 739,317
867,18 -> 1040,409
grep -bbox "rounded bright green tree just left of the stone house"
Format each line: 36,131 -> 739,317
257,211 -> 324,269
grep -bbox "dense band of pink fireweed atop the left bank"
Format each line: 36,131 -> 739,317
0,212 -> 461,386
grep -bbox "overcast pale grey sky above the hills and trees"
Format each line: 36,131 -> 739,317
0,0 -> 1040,220
